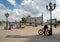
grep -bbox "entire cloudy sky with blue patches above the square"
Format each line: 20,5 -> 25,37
0,0 -> 60,21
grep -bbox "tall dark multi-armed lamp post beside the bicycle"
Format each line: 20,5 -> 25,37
46,2 -> 56,35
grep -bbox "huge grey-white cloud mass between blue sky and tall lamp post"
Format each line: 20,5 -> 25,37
9,0 -> 55,20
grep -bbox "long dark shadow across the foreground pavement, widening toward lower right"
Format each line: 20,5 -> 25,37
6,34 -> 60,42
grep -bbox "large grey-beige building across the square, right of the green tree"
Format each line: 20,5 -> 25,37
27,16 -> 43,24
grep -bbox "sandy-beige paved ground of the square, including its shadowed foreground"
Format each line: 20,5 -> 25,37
0,26 -> 60,42
